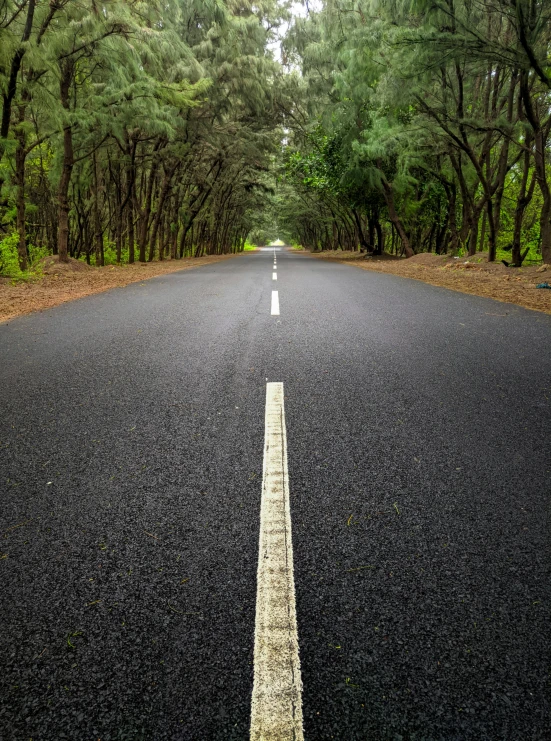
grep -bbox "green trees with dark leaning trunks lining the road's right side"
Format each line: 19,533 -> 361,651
277,0 -> 551,262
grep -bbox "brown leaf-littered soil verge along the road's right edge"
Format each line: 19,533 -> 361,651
312,251 -> 551,314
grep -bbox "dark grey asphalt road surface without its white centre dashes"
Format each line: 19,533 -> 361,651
0,251 -> 551,741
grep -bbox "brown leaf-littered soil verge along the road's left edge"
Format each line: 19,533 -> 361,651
0,255 -> 236,322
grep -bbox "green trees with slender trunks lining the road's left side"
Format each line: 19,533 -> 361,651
0,0 -> 289,270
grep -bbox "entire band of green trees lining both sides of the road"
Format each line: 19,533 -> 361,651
0,0 -> 551,270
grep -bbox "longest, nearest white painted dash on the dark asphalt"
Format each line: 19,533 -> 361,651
250,383 -> 304,741
